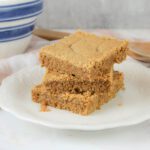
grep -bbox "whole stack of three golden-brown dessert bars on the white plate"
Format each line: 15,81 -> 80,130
32,31 -> 128,115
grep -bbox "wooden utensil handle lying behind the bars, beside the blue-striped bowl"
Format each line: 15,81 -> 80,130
33,28 -> 69,41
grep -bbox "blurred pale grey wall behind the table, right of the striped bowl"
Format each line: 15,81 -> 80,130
38,0 -> 150,29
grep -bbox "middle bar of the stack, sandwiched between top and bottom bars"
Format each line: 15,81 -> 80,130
43,69 -> 113,94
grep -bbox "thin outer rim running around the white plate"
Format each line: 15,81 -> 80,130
0,61 -> 150,131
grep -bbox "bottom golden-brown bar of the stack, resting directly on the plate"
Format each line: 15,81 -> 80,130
32,72 -> 124,115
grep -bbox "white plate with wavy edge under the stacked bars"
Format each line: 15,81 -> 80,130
0,60 -> 150,130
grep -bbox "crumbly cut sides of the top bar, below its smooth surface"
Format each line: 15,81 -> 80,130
39,48 -> 128,80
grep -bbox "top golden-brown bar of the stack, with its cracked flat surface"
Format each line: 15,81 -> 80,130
40,31 -> 128,80
